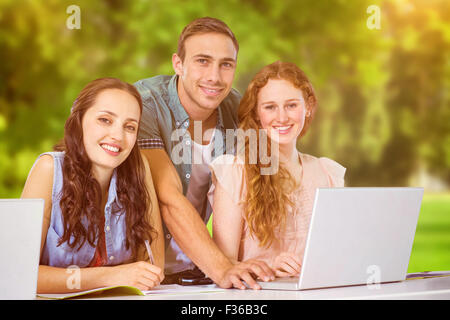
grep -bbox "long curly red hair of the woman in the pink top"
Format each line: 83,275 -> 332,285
238,61 -> 317,247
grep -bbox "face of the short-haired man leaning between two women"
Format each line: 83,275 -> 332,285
172,33 -> 237,117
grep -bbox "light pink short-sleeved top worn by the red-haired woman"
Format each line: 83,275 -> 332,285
208,153 -> 346,266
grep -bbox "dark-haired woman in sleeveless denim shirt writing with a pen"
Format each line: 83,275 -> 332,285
22,78 -> 164,293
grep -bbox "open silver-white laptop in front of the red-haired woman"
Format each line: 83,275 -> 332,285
258,188 -> 424,290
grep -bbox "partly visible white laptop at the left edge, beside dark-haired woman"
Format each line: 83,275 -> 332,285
0,199 -> 44,300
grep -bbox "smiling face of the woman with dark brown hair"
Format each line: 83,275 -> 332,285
82,89 -> 140,176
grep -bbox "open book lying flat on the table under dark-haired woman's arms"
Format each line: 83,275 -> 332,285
37,284 -> 226,299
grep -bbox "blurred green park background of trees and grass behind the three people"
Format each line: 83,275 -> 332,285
0,0 -> 450,272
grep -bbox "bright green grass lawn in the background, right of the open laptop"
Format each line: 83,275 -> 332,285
208,193 -> 450,273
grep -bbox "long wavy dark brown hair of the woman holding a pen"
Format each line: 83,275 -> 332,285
55,78 -> 156,258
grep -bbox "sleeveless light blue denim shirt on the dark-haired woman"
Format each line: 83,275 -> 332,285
40,152 -> 132,268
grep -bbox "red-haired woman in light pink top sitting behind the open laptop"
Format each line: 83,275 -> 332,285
209,61 -> 345,277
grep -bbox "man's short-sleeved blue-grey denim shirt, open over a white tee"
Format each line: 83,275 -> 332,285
134,75 -> 241,274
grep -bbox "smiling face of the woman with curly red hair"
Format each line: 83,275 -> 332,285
257,79 -> 306,148
